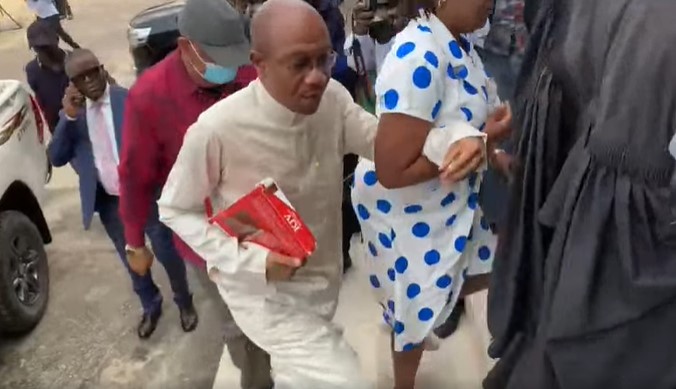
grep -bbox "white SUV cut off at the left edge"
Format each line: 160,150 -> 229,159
0,80 -> 52,335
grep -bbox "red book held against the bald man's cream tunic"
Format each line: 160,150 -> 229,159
207,179 -> 317,260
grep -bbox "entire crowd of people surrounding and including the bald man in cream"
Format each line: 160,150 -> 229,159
19,0 -> 676,389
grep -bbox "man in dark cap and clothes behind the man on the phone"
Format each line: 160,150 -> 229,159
26,20 -> 70,132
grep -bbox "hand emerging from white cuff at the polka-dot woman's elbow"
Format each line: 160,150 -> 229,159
439,137 -> 486,182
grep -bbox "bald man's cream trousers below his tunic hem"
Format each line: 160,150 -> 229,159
214,274 -> 371,389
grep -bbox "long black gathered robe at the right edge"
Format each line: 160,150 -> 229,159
484,0 -> 676,389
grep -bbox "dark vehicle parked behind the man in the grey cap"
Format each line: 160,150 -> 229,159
127,0 -> 185,75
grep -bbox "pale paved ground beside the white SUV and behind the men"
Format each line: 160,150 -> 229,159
0,0 -> 223,389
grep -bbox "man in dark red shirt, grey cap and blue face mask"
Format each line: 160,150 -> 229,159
119,0 -> 273,389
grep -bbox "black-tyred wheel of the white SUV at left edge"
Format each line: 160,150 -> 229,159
0,211 -> 49,335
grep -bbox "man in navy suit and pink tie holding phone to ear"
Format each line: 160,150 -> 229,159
48,50 -> 198,338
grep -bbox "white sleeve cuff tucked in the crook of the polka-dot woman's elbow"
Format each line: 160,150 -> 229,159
423,120 -> 486,166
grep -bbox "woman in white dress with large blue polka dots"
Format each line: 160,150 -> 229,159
352,0 -> 504,388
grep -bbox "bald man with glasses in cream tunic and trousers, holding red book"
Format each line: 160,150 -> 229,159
159,0 -> 472,389
